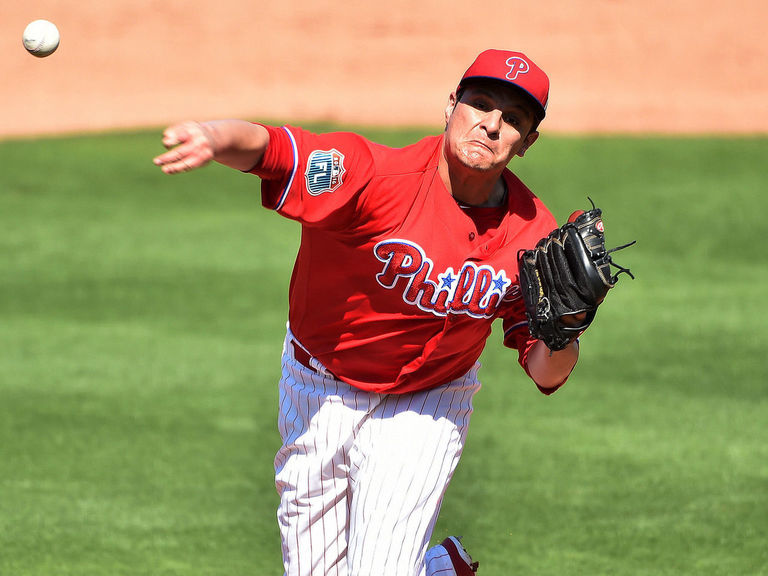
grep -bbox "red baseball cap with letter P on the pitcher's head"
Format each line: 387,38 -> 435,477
459,50 -> 549,122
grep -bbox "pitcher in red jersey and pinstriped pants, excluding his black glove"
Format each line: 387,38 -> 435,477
154,50 -> 578,576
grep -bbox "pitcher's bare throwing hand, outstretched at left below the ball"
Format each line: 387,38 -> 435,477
154,122 -> 215,174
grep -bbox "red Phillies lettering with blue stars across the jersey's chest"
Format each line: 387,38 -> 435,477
373,240 -> 512,318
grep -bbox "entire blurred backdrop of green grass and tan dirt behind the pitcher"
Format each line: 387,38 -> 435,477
0,0 -> 768,576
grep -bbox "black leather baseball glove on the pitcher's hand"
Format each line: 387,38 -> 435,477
518,198 -> 635,350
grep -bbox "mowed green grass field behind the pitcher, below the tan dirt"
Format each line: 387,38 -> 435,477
0,130 -> 768,576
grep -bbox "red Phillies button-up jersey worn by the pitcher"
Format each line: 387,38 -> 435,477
253,127 -> 557,393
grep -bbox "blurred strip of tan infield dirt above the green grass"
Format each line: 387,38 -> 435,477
6,0 -> 768,136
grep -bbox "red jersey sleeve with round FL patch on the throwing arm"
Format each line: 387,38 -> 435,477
251,126 -> 374,228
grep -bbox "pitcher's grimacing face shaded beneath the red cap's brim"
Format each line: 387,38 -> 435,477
445,83 -> 539,171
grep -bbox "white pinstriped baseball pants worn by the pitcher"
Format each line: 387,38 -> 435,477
275,330 -> 480,576
